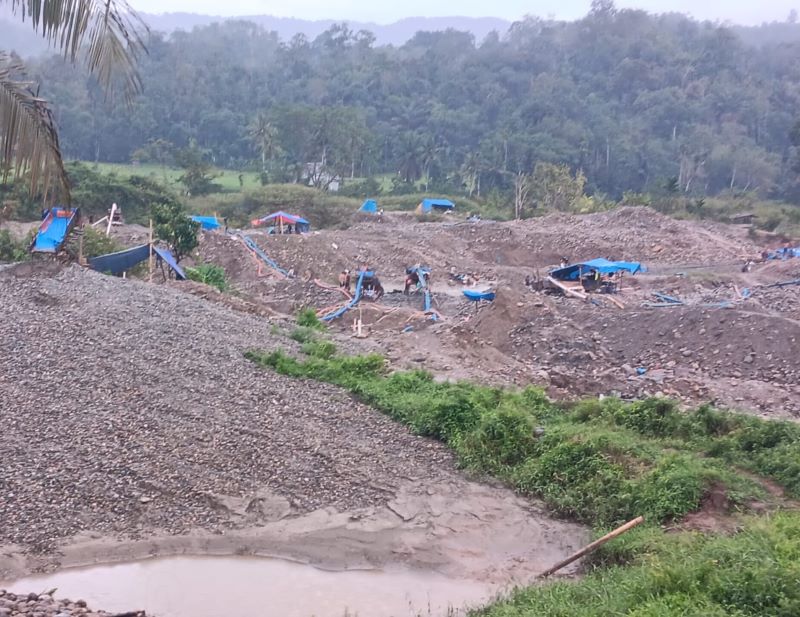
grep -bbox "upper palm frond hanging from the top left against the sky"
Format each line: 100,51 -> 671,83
0,0 -> 148,100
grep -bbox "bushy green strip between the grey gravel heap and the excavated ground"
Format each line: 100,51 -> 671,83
248,346 -> 800,527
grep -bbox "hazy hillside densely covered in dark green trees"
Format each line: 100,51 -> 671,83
25,2 -> 800,199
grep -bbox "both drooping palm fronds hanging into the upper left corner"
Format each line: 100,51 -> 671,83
0,0 -> 147,203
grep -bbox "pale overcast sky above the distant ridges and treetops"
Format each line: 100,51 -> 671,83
129,0 -> 800,24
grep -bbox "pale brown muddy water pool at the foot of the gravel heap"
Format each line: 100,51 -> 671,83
0,557 -> 497,617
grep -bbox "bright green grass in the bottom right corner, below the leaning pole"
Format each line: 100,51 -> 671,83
472,513 -> 800,617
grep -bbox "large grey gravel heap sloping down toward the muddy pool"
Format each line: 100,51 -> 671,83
0,263 -> 453,552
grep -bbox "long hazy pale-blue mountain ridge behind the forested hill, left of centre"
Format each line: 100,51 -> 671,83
142,13 -> 511,45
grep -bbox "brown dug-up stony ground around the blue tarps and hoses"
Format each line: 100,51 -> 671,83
181,208 -> 800,418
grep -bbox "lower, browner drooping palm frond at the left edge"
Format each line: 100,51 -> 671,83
0,51 -> 69,203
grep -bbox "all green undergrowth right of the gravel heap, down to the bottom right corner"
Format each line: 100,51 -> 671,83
246,343 -> 800,617
